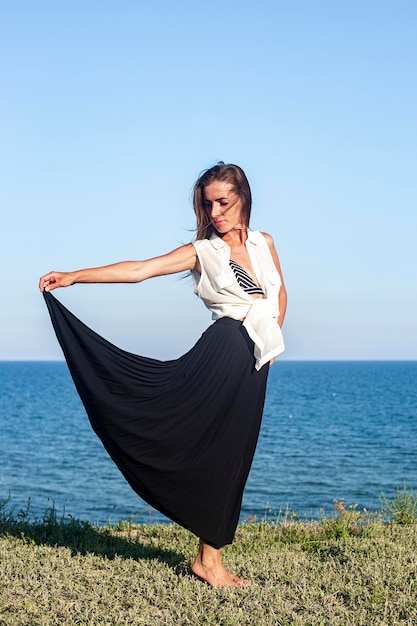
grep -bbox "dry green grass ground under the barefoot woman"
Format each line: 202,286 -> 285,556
0,485 -> 417,626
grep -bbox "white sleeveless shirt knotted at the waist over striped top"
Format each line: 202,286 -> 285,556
192,230 -> 285,370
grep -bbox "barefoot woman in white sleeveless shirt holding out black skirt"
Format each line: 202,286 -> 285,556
40,162 -> 287,586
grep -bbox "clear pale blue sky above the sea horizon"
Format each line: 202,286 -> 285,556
0,0 -> 417,360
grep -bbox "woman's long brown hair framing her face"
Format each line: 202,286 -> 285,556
193,161 -> 252,239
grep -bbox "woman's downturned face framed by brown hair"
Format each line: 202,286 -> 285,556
203,180 -> 243,235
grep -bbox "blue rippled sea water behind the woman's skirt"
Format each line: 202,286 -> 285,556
0,361 -> 417,524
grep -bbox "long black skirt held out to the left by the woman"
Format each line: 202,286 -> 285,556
44,292 -> 269,548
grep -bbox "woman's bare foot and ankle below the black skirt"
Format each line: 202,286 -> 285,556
191,539 -> 251,587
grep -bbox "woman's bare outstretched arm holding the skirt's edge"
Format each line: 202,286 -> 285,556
39,244 -> 197,291
